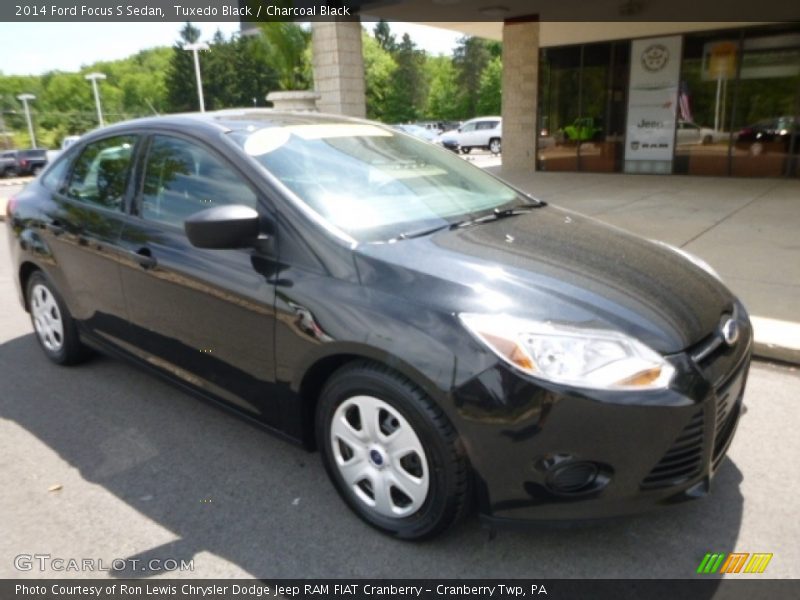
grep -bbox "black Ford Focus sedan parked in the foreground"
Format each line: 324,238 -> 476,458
7,111 -> 752,538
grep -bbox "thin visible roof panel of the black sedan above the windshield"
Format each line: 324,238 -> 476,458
86,108 -> 376,137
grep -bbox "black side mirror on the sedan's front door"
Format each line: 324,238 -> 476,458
183,204 -> 261,250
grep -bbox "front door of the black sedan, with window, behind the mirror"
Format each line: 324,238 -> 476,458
115,135 -> 280,427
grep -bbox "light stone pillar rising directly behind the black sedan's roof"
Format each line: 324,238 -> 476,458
311,21 -> 367,118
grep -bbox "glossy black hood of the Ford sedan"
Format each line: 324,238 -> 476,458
356,206 -> 735,354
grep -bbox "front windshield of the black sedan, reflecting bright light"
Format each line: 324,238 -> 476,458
232,123 -> 530,242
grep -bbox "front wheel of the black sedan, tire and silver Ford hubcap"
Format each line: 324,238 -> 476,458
316,361 -> 471,540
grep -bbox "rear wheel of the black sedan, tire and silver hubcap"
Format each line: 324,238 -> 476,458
26,271 -> 89,365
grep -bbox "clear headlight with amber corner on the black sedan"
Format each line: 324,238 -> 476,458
459,313 -> 675,390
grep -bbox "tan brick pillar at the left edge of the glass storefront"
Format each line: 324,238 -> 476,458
503,17 -> 539,171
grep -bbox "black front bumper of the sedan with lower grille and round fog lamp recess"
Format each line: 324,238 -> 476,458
454,309 -> 752,521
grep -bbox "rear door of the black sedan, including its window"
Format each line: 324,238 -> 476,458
44,135 -> 137,343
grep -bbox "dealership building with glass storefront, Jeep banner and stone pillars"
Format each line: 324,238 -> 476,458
270,0 -> 800,177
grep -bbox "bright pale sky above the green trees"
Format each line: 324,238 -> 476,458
0,22 -> 460,75
